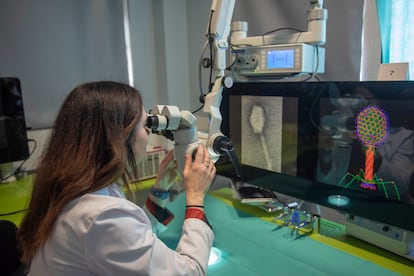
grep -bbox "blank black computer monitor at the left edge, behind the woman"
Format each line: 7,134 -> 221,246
0,78 -> 29,168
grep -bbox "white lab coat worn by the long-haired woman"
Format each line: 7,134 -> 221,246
29,185 -> 214,276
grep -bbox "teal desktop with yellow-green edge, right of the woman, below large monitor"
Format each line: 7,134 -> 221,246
159,188 -> 414,276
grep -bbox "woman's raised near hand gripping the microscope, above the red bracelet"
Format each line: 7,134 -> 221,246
183,144 -> 216,205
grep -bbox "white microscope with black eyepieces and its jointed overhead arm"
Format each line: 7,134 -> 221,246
147,0 -> 241,176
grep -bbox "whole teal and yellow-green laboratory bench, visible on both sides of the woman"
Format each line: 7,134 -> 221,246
0,177 -> 414,276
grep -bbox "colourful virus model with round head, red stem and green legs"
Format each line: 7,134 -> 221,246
339,106 -> 401,200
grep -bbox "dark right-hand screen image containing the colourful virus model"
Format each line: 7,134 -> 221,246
317,85 -> 414,202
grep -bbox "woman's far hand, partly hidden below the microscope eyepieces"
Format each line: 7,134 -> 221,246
154,150 -> 180,191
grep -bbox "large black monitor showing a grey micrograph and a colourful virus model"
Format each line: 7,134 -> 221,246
222,81 -> 414,230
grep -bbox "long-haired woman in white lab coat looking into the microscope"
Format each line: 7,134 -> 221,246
18,81 -> 216,276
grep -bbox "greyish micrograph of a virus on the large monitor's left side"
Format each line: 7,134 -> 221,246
230,95 -> 298,175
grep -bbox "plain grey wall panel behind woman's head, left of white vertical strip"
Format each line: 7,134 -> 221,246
0,0 -> 128,129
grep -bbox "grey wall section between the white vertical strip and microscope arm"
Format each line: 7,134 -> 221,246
129,0 -> 196,110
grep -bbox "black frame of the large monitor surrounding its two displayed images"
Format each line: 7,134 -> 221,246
217,81 -> 414,231
